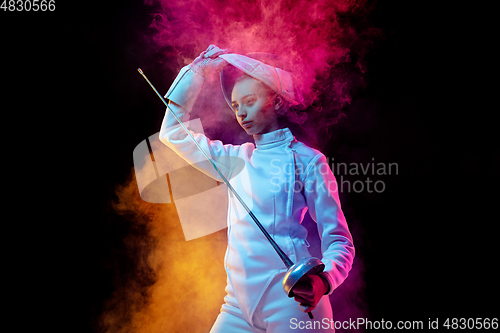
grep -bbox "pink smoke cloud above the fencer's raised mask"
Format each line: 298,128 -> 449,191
145,0 -> 377,117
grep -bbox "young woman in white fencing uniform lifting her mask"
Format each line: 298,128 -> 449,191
160,45 -> 354,333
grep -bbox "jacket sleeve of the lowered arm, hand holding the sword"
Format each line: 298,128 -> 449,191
304,154 -> 355,295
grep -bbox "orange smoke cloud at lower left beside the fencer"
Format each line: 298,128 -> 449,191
100,169 -> 227,333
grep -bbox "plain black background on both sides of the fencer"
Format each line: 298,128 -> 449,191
0,1 -> 498,332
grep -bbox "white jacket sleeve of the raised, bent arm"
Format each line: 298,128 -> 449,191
159,66 -> 237,181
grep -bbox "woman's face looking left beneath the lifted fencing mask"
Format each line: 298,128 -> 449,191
231,76 -> 279,135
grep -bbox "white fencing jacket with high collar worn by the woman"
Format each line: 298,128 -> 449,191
160,66 -> 354,318
